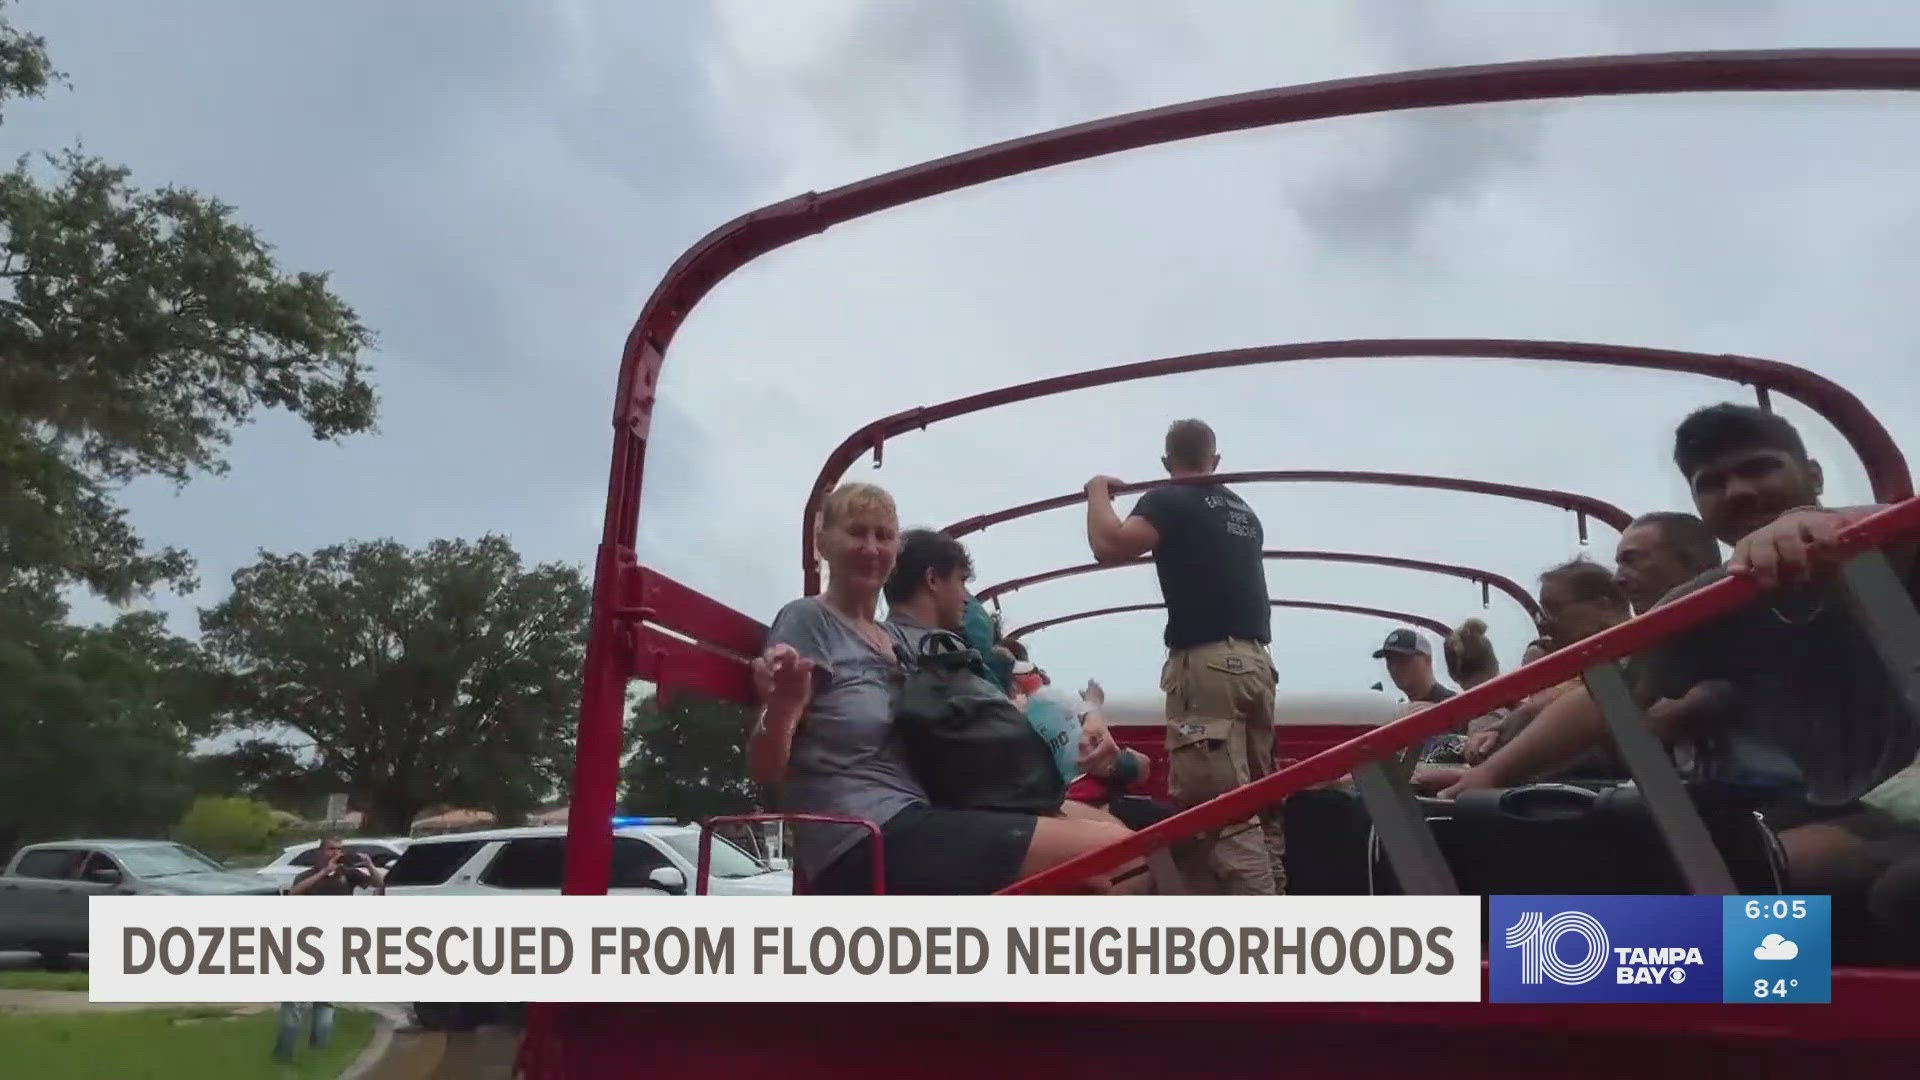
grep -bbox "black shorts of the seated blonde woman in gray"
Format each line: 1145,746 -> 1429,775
806,805 -> 1039,896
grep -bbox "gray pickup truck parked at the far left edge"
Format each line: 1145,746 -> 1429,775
0,840 -> 280,969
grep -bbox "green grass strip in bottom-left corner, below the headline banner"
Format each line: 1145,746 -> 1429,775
0,1007 -> 374,1080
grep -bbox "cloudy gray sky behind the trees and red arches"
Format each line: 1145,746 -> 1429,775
18,0 -> 1920,694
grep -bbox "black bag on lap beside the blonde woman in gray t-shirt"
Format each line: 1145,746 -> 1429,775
893,630 -> 1068,817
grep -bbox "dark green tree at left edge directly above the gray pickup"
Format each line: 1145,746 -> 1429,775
0,576 -> 215,846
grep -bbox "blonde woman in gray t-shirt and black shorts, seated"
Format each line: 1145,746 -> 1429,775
747,484 -> 1144,896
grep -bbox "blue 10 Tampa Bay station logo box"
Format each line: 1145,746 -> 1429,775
1486,896 -> 1728,1005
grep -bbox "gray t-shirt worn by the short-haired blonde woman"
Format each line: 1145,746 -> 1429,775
766,598 -> 927,876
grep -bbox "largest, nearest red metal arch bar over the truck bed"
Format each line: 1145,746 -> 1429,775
563,50 -> 1920,896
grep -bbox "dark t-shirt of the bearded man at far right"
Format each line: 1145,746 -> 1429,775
1644,569 -> 1920,807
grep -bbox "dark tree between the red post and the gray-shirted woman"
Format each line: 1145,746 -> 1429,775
620,694 -> 756,819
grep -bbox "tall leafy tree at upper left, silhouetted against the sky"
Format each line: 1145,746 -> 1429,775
0,0 -> 374,600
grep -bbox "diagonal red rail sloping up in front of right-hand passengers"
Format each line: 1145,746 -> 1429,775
1000,498 -> 1920,894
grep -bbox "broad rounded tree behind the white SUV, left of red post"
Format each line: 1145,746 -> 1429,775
200,536 -> 589,832
